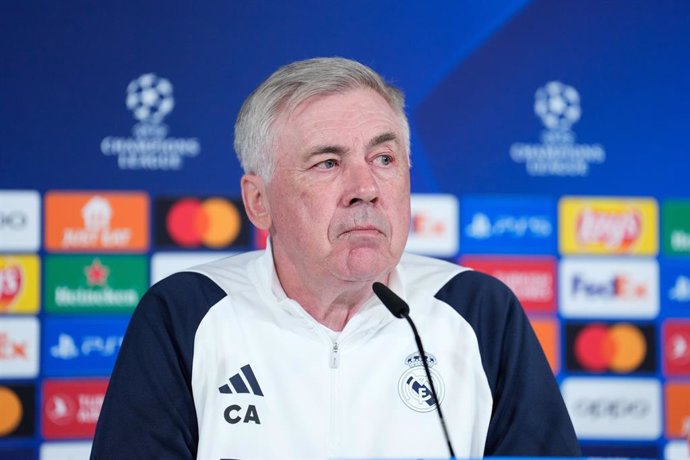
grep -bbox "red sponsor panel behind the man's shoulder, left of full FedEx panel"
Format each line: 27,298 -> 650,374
460,256 -> 556,313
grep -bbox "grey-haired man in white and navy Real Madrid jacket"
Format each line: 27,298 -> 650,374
92,58 -> 579,459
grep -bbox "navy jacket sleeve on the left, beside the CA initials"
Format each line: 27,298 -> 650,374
91,273 -> 225,460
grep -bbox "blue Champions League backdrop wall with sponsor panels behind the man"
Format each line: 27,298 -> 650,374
0,0 -> 690,459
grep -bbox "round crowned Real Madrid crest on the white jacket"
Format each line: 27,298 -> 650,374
398,353 -> 446,412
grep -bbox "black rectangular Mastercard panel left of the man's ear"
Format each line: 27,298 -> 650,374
156,197 -> 250,249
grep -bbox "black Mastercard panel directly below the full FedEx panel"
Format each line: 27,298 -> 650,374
567,323 -> 655,373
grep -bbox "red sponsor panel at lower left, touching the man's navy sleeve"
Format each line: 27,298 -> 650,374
42,379 -> 108,439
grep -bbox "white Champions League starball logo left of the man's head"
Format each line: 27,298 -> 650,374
101,73 -> 201,171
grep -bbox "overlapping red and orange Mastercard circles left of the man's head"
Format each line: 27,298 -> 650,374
165,198 -> 242,249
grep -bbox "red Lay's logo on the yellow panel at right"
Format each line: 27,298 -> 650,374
577,208 -> 642,250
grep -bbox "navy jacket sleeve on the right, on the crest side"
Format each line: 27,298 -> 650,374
436,271 -> 581,457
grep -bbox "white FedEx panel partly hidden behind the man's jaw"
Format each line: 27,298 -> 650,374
406,194 -> 459,257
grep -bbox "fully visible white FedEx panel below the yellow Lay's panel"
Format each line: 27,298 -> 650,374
559,258 -> 659,319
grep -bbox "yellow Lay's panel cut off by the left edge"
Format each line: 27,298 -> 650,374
0,255 -> 40,314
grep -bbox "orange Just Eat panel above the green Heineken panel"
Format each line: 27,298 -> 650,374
45,192 -> 149,252
